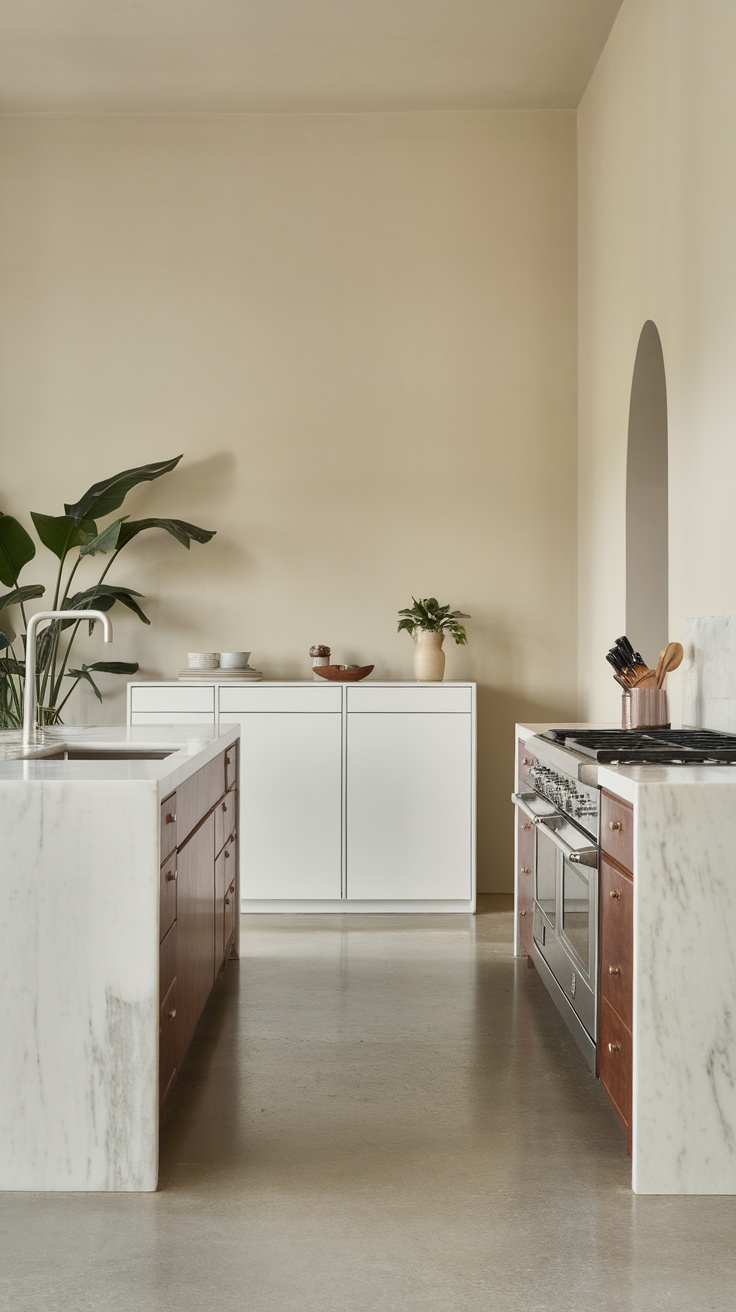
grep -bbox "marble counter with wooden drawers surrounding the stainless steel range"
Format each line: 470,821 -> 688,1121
516,724 -> 736,1194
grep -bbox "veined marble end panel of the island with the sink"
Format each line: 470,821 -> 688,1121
0,779 -> 159,1190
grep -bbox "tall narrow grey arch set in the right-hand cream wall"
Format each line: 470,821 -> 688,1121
626,319 -> 669,668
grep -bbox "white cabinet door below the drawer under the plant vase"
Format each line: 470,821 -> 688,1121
346,712 -> 472,900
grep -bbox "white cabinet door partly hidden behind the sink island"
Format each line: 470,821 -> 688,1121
232,711 -> 342,901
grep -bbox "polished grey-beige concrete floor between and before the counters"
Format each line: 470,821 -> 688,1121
0,901 -> 736,1312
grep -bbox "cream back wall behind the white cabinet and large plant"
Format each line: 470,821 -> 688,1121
0,113 -> 577,891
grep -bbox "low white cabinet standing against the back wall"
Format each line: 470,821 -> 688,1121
129,680 -> 475,912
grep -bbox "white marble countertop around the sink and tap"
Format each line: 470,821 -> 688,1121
0,724 -> 240,796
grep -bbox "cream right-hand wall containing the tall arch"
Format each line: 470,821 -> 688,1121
579,0 -> 736,719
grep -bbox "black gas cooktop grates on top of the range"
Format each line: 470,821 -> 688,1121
539,729 -> 736,765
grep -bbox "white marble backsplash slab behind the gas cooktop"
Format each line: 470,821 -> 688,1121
682,615 -> 736,733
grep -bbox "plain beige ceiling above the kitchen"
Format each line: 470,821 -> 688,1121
0,0 -> 622,113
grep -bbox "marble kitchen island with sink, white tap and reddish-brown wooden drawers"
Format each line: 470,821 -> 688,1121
0,726 -> 239,1190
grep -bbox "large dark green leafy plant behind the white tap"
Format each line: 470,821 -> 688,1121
0,455 -> 214,728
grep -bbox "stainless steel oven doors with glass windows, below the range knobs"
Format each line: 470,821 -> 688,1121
534,815 -> 598,1042
